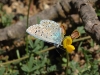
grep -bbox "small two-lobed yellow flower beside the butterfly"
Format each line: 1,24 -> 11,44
63,36 -> 75,53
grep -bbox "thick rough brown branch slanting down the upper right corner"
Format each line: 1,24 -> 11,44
72,0 -> 100,42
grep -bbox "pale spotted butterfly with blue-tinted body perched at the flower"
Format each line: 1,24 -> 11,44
26,20 -> 64,46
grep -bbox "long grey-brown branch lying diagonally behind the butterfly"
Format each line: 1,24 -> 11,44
0,0 -> 99,41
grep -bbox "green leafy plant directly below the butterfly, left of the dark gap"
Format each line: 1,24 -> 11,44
21,39 -> 56,75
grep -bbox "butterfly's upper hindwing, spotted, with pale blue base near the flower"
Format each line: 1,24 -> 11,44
40,20 -> 63,45
